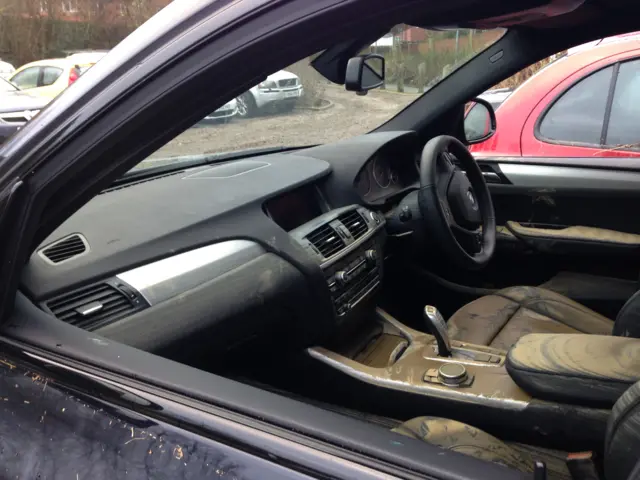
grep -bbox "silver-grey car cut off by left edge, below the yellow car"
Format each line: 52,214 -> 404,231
0,78 -> 49,144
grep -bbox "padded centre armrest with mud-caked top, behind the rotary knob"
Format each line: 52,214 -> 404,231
506,334 -> 640,407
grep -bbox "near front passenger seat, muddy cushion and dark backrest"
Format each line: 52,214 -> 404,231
392,382 -> 640,480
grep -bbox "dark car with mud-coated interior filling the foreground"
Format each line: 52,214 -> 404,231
0,0 -> 640,480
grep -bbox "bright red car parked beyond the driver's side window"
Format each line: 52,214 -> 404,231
471,35 -> 640,160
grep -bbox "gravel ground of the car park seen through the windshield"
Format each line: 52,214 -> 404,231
150,86 -> 417,162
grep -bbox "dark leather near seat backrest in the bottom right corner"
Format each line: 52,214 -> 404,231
604,382 -> 640,480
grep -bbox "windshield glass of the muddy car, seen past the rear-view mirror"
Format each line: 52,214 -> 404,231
136,25 -> 504,169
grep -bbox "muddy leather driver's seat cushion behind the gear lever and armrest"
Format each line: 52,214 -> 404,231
448,287 -> 613,350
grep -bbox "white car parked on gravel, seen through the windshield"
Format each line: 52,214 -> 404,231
238,70 -> 303,118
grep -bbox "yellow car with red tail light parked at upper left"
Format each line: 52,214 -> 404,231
9,52 -> 106,98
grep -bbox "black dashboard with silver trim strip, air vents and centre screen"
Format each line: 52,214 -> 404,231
20,132 -> 420,359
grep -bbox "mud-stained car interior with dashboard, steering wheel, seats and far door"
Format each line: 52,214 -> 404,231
6,0 -> 640,479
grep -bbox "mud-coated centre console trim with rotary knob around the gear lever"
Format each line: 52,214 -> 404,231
308,309 -> 531,410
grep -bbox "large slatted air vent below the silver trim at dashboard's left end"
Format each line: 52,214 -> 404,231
47,283 -> 137,330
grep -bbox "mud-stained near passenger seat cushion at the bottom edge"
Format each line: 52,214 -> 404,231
393,417 -> 570,479
